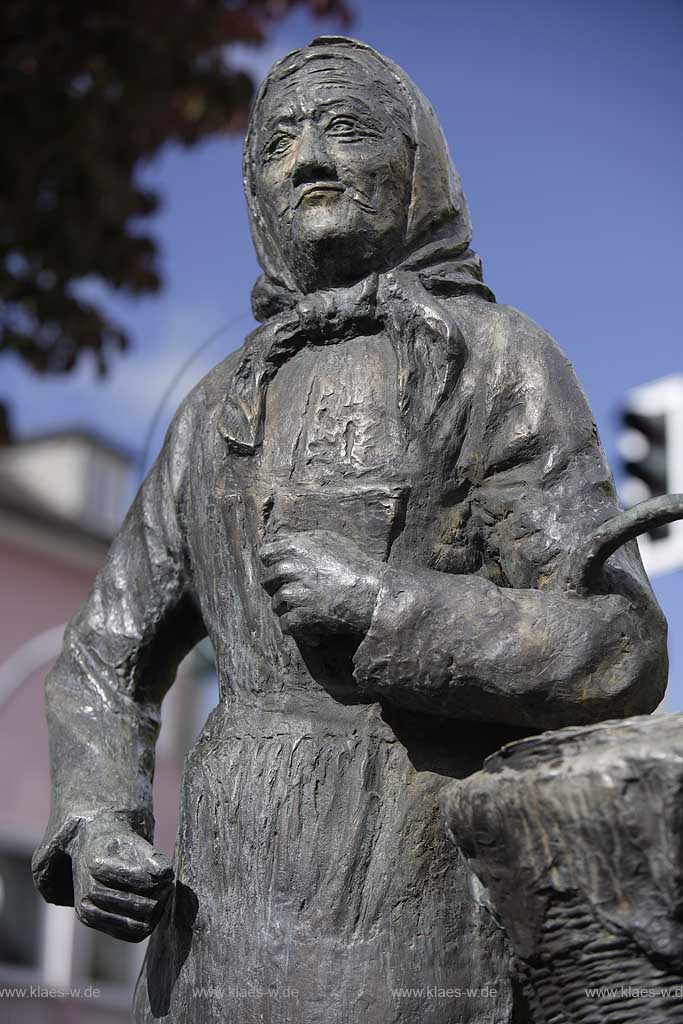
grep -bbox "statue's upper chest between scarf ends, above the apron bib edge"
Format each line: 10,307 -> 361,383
259,335 -> 404,482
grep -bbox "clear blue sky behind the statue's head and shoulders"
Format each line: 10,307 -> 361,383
0,0 -> 683,696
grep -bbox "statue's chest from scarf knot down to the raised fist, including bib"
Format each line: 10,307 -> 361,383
252,335 -> 411,559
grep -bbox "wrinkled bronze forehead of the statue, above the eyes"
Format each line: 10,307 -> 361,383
252,50 -> 414,138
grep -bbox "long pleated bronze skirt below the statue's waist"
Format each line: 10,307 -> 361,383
134,703 -> 512,1024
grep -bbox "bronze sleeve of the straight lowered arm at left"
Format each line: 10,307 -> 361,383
33,397 -> 205,905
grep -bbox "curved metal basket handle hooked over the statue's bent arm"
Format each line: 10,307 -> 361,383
567,495 -> 683,594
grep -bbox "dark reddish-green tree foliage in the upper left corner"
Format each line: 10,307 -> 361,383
0,0 -> 349,373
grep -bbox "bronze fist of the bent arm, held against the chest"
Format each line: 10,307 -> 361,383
259,529 -> 384,640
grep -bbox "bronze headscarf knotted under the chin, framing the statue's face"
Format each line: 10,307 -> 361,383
220,36 -> 496,455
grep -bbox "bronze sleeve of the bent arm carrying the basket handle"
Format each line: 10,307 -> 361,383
354,307 -> 668,728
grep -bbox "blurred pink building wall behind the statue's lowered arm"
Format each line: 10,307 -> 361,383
0,515 -> 193,1024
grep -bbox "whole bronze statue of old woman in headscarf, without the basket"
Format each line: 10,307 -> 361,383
34,38 -> 667,1024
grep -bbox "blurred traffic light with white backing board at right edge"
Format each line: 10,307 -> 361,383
618,375 -> 683,574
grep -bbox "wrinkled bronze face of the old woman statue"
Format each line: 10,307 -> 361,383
250,57 -> 413,291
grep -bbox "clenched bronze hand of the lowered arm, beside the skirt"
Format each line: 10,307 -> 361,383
71,819 -> 173,942
